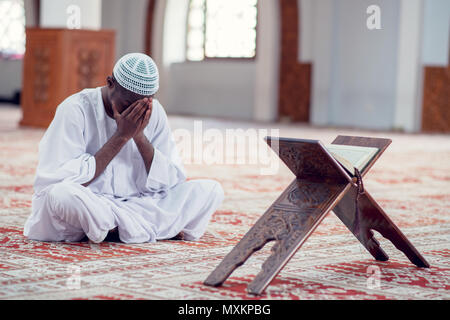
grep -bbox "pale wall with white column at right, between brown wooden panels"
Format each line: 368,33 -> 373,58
306,0 -> 450,132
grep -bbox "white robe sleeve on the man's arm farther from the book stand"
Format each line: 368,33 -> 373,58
34,98 -> 96,194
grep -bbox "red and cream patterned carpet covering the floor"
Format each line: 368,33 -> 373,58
0,106 -> 450,300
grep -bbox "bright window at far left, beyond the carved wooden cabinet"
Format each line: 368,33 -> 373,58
0,0 -> 25,58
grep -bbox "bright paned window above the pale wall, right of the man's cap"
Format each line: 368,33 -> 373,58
186,0 -> 258,61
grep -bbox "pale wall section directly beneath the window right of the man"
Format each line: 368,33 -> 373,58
165,61 -> 255,120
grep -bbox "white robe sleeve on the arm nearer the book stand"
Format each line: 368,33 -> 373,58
139,100 -> 186,194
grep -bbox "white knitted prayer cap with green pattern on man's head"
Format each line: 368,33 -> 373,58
113,53 -> 159,96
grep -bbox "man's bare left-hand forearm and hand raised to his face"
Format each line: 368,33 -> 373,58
82,100 -> 148,187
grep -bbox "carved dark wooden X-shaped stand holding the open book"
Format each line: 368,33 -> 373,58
204,136 -> 430,295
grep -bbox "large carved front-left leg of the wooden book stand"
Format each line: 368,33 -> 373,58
204,180 -> 348,294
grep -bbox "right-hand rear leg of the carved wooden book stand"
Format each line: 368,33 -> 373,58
333,188 -> 430,268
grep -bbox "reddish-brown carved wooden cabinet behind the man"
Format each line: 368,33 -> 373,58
20,28 -> 115,128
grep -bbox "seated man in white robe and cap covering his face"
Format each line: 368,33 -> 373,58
24,53 -> 223,243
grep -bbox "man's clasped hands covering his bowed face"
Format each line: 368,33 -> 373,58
112,98 -> 153,140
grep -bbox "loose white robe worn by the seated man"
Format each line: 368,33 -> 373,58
24,87 -> 223,243
